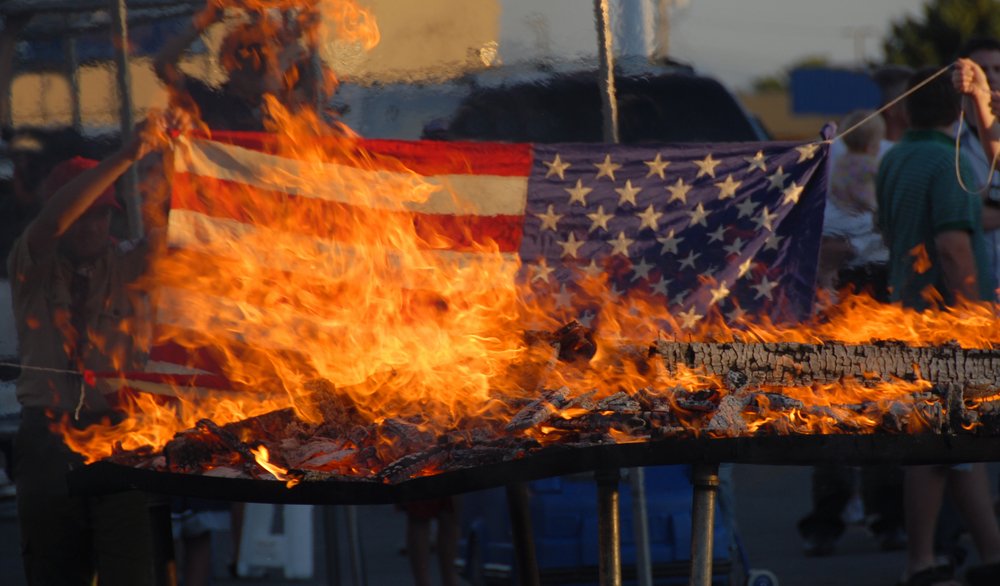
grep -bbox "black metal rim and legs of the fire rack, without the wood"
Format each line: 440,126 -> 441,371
69,432 -> 1000,586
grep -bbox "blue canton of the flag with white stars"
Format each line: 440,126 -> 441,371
520,143 -> 828,328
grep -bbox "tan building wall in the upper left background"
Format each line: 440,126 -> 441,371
11,0 -> 500,128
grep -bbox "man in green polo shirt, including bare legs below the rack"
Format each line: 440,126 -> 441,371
876,69 -> 1000,585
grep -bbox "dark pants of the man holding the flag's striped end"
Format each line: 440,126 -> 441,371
14,409 -> 154,586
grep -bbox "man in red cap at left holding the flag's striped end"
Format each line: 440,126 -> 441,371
7,113 -> 177,586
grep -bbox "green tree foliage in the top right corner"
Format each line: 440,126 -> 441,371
882,0 -> 1000,67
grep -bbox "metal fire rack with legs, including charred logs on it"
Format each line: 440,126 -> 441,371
64,322 -> 1000,586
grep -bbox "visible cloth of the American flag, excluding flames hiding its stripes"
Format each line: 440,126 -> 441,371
109,133 -> 828,392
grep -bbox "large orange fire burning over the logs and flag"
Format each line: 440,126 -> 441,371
58,0 -> 1000,479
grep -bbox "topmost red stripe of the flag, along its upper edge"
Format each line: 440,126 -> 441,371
212,131 -> 533,177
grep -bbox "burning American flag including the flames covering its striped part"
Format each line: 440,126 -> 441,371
73,116 -> 827,472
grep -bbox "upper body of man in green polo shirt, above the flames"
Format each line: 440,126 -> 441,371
876,69 -> 996,309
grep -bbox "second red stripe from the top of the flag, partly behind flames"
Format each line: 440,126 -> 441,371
170,173 -> 523,252
